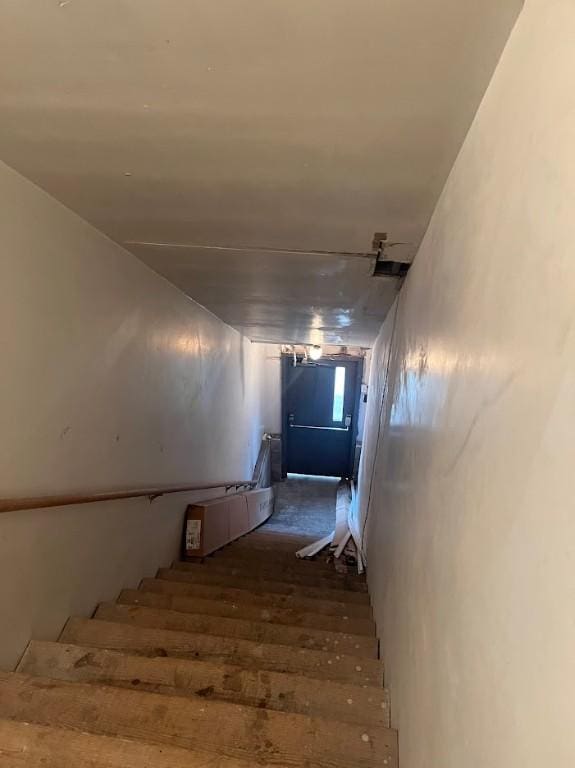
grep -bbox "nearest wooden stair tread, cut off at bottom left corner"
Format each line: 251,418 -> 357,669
0,720 -> 256,768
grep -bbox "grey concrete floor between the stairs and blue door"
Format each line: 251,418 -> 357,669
266,475 -> 339,539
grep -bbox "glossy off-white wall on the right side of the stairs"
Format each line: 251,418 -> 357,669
360,0 -> 575,768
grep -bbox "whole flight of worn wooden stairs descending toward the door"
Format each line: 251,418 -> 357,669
0,526 -> 397,768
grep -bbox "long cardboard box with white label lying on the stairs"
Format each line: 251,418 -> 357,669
184,488 -> 274,557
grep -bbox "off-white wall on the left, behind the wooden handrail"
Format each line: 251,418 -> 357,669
0,165 -> 270,668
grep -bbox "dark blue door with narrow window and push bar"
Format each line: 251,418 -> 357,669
282,355 -> 363,478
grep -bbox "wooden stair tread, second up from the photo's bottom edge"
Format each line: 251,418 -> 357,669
0,672 -> 397,768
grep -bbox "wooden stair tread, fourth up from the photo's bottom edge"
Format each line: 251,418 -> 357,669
60,618 -> 383,687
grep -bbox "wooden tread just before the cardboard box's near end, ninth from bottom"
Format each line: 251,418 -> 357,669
172,557 -> 367,593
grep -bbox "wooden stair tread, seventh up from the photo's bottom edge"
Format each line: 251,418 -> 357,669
140,578 -> 372,620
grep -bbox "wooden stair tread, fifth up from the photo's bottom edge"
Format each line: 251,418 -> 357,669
115,589 -> 378,659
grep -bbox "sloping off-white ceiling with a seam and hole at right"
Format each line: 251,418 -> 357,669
0,0 -> 522,346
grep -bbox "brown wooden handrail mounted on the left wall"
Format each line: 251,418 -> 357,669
0,480 -> 255,513
